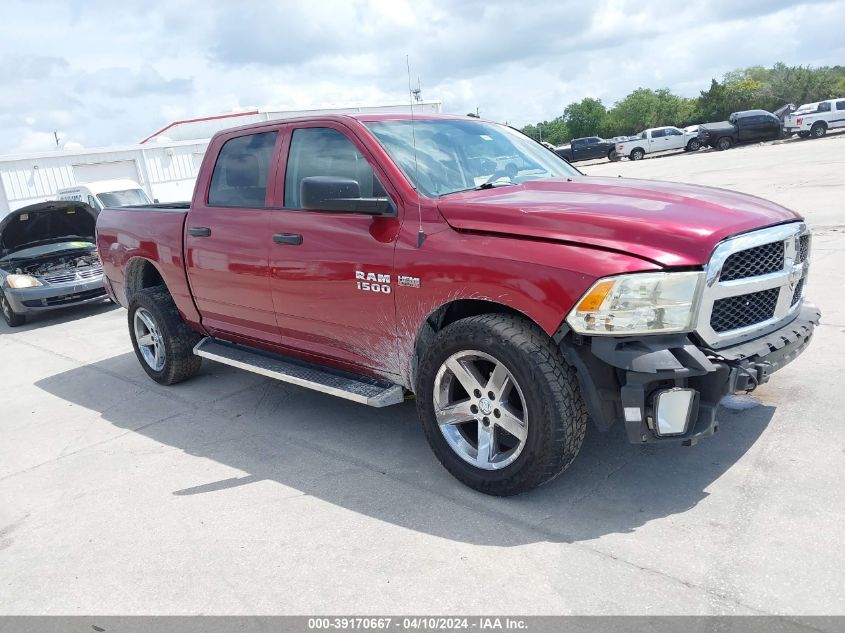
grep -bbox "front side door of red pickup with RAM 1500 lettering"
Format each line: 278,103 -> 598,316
266,122 -> 399,372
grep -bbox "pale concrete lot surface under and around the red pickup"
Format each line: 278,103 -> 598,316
0,135 -> 845,615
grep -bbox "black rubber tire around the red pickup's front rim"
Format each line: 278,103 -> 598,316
416,314 -> 587,496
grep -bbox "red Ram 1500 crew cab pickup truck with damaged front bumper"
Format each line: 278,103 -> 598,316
97,115 -> 820,495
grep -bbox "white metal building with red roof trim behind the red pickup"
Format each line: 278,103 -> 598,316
0,101 -> 441,217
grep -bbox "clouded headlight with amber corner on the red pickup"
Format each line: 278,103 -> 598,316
566,272 -> 704,336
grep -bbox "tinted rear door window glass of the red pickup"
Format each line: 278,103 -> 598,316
208,132 -> 278,209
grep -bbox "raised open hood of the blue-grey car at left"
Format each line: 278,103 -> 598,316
0,200 -> 97,257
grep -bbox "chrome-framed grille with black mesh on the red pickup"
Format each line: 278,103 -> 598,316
696,222 -> 810,349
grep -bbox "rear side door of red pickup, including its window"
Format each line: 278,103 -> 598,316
185,130 -> 280,343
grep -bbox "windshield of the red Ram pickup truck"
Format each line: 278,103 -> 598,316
365,119 -> 579,198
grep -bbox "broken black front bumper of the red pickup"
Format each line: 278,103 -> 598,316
560,301 -> 821,444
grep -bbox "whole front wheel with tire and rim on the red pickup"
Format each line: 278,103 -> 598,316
415,314 -> 587,496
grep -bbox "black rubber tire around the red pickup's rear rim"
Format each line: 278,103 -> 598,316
129,286 -> 202,385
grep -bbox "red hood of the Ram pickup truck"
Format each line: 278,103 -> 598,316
438,177 -> 801,267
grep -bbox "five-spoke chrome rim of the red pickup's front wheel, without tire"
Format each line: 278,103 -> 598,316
434,350 -> 528,470
